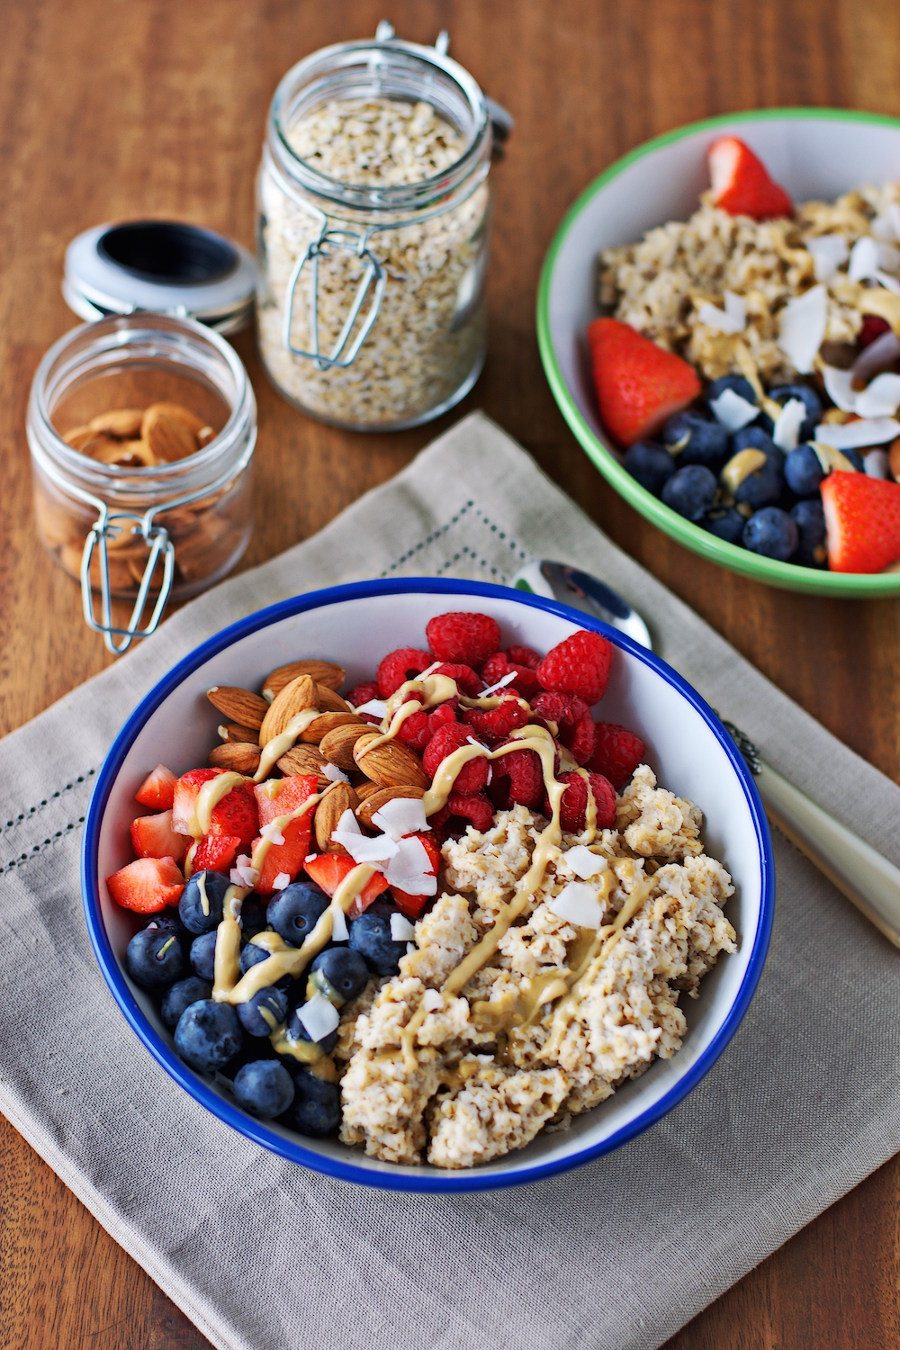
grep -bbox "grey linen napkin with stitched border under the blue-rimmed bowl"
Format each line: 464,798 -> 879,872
0,416 -> 900,1350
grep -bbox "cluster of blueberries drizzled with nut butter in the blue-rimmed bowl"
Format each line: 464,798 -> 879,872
125,872 -> 406,1135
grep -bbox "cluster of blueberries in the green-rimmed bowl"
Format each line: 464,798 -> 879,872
625,375 -> 847,567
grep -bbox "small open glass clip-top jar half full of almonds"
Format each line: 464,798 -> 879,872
27,313 -> 256,651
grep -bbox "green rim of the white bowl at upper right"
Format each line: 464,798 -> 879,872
534,107 -> 900,599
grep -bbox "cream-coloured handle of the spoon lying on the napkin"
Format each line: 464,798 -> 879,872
756,763 -> 900,948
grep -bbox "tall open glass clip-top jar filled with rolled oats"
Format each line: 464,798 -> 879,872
256,24 -> 493,431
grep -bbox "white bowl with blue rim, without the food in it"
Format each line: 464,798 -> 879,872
82,579 -> 775,1192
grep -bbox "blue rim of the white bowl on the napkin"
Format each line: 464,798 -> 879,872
81,576 -> 775,1193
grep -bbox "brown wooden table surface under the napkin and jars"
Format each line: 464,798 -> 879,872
0,0 -> 900,1350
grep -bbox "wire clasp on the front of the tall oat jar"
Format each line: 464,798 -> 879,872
283,230 -> 387,370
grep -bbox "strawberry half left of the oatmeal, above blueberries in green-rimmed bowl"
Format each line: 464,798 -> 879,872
587,319 -> 700,446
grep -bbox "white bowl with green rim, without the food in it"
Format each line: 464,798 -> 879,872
537,108 -> 900,598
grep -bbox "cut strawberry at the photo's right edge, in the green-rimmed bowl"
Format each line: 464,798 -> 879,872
820,471 -> 900,572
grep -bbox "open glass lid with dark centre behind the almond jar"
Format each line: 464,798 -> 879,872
62,220 -> 256,333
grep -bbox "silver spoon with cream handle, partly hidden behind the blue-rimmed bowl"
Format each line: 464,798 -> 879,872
513,560 -> 900,948
